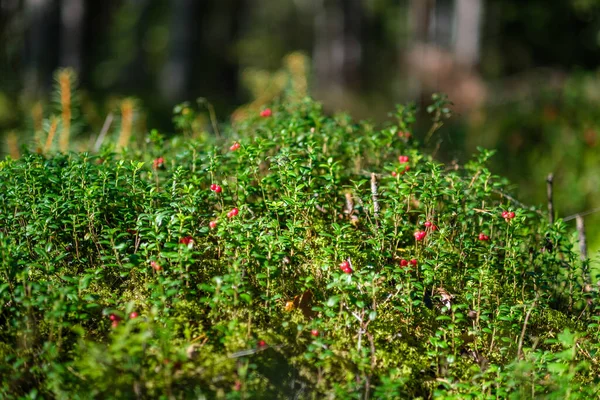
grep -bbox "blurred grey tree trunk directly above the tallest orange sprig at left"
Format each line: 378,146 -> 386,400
60,0 -> 85,75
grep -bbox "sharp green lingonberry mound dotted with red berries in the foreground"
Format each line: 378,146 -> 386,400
0,97 -> 600,399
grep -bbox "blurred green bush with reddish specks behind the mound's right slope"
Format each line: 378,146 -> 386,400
462,73 -> 600,252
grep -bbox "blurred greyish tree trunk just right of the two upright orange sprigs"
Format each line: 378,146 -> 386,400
159,0 -> 196,103
